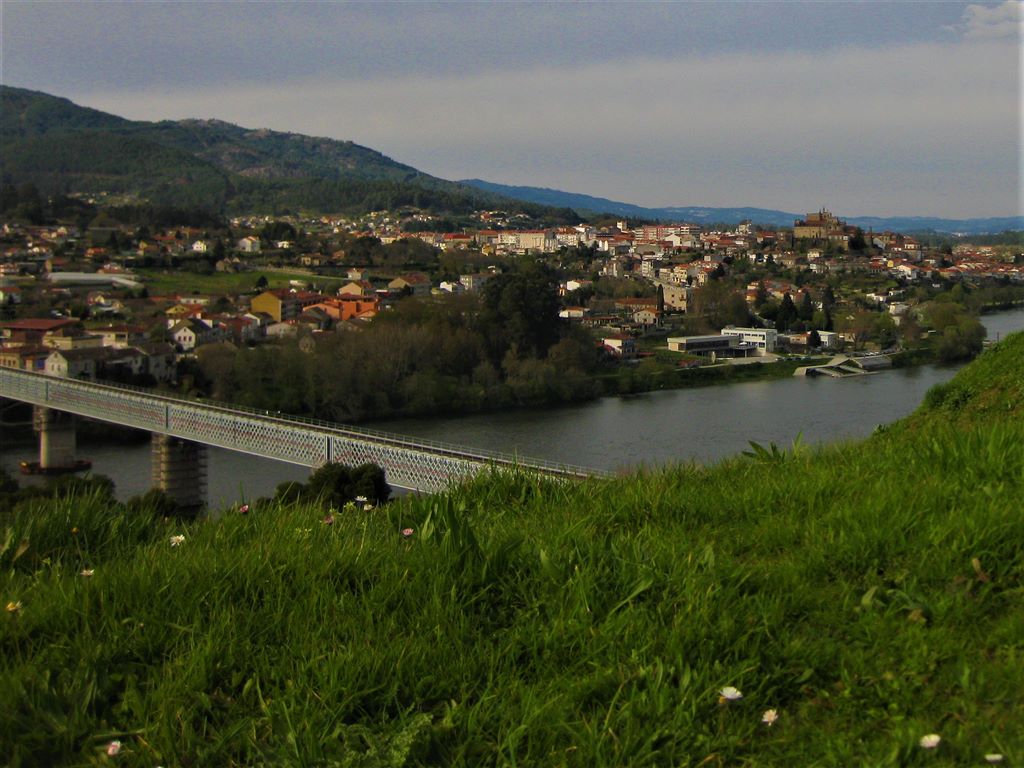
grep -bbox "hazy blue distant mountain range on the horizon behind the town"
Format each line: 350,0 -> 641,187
460,178 -> 1024,234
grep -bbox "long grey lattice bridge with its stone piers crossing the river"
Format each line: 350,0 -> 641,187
0,368 -> 601,506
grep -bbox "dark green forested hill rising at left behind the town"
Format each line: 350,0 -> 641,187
0,86 -> 573,220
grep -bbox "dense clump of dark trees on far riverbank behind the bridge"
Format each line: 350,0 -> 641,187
196,262 -> 597,421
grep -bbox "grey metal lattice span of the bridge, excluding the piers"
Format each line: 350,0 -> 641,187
0,368 -> 604,492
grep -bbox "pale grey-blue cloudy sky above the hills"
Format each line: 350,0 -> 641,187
0,0 -> 1024,218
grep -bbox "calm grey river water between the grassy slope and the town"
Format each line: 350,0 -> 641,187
0,308 -> 1024,507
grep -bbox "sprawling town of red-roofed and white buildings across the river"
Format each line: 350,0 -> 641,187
0,202 -> 1024,418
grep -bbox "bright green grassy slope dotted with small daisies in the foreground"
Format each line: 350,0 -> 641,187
0,334 -> 1024,766
